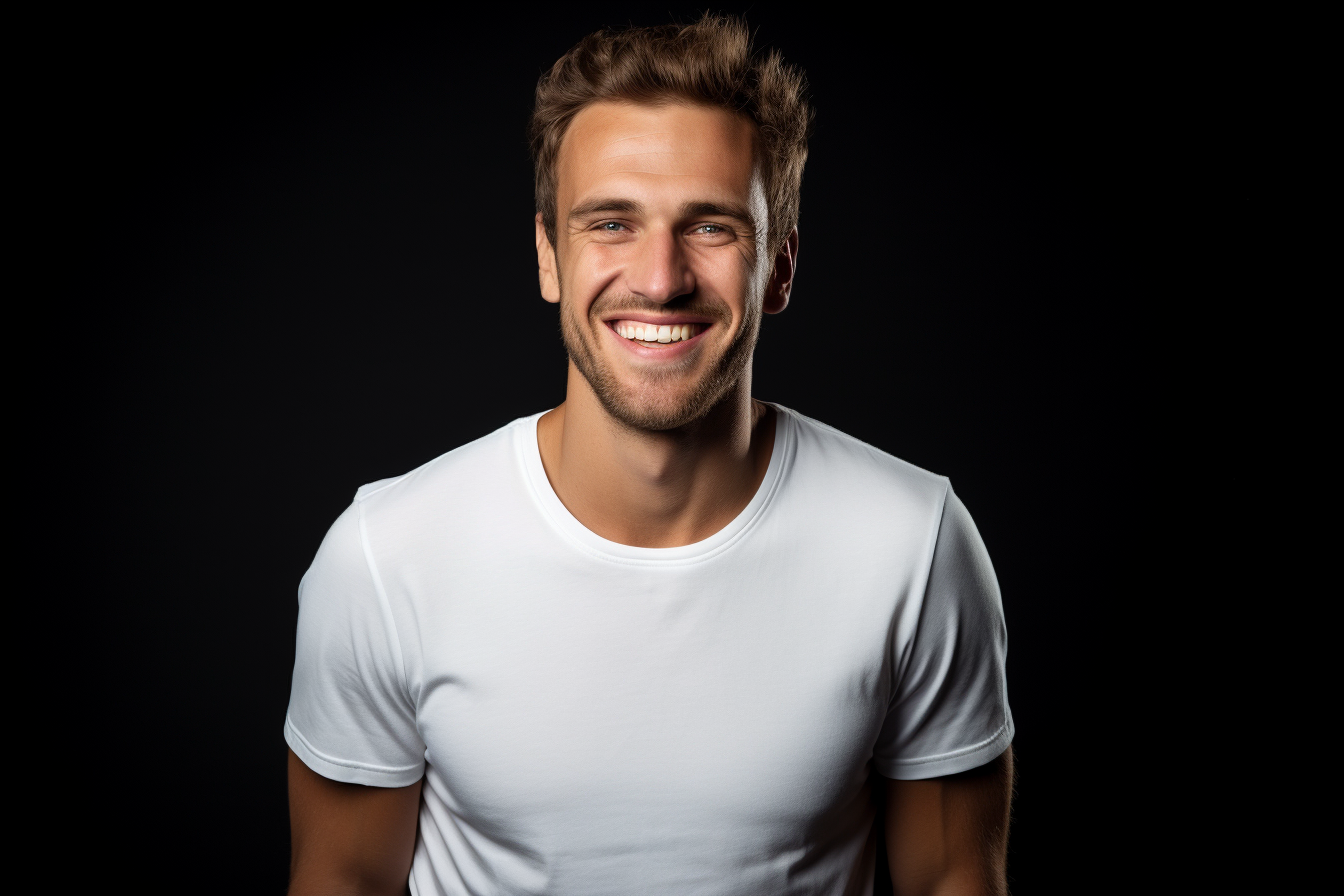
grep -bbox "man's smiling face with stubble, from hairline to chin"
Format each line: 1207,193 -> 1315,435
538,102 -> 782,430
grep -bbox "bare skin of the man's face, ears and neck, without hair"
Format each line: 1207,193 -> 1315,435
535,102 -> 798,548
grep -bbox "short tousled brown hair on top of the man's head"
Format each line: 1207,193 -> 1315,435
530,13 -> 812,251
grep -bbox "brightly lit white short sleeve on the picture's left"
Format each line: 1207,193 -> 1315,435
285,501 -> 425,787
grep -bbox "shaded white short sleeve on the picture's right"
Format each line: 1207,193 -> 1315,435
874,488 -> 1013,780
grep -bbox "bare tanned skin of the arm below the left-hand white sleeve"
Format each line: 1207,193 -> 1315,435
289,750 -> 421,896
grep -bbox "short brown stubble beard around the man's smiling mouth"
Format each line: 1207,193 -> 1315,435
560,287 -> 761,431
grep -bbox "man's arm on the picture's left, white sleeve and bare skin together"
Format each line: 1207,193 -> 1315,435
285,504 -> 425,896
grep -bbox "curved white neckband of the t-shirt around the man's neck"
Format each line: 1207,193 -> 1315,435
513,402 -> 794,566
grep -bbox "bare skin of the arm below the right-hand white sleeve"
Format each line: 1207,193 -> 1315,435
886,747 -> 1012,896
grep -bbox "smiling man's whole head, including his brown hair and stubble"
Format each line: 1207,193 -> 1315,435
532,16 -> 810,430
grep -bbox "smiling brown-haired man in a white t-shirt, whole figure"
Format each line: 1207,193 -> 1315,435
285,17 -> 1013,896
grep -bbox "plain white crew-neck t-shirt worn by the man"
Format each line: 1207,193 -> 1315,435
285,408 -> 1013,896
